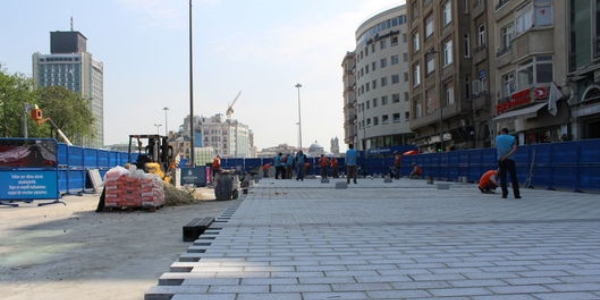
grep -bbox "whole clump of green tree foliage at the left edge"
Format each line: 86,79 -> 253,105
0,69 -> 95,144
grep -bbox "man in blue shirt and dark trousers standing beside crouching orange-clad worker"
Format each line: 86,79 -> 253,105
496,128 -> 521,199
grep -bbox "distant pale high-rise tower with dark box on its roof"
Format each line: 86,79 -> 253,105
33,31 -> 104,148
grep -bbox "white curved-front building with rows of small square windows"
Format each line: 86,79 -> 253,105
350,5 -> 413,150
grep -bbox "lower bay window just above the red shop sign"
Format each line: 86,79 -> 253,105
517,56 -> 554,90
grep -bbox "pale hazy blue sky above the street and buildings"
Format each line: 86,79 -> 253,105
0,0 -> 404,151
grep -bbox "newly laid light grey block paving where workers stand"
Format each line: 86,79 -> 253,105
145,178 -> 600,300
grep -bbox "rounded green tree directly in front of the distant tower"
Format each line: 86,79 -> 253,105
36,86 -> 96,144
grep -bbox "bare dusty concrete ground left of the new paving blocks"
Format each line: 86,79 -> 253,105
0,191 -> 231,300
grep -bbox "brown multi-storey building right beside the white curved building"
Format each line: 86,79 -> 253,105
408,0 -> 476,152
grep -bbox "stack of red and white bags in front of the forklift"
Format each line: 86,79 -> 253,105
104,166 -> 165,208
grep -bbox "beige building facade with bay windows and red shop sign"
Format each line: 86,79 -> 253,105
487,0 -> 568,144
